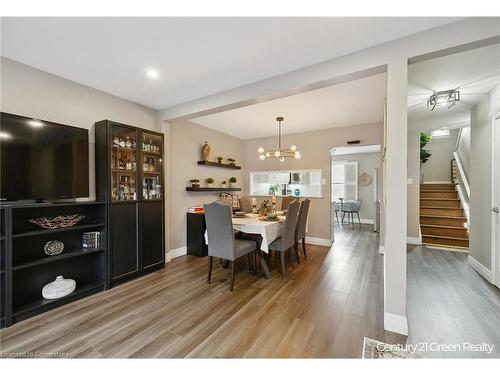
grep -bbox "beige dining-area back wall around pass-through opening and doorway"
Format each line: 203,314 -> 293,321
244,123 -> 382,239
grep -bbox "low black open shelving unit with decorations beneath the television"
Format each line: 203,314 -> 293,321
0,201 -> 107,327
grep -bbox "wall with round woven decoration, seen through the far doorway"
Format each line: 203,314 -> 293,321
333,152 -> 382,220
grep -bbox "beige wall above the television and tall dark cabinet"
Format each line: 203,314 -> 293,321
1,58 -> 159,199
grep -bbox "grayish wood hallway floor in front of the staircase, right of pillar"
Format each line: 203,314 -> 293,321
408,245 -> 500,358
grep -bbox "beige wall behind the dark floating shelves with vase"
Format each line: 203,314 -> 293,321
167,121 -> 246,250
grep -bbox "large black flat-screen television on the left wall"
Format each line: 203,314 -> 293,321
0,112 -> 89,201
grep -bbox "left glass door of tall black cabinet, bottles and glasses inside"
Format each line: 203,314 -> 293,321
111,125 -> 137,201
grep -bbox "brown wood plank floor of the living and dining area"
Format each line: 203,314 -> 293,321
0,226 -> 406,358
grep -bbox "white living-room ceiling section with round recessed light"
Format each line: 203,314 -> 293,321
1,17 -> 459,109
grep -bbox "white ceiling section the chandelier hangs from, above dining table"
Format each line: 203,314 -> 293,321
191,73 -> 387,139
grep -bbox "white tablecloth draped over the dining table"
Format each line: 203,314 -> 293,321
205,215 -> 284,253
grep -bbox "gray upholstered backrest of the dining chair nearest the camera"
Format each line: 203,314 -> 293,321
203,201 -> 235,259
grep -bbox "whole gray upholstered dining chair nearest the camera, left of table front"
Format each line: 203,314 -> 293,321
204,202 -> 256,290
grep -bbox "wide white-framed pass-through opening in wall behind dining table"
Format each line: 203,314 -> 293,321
250,169 -> 321,198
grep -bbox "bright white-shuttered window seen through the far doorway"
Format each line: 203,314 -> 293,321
332,161 -> 358,202
